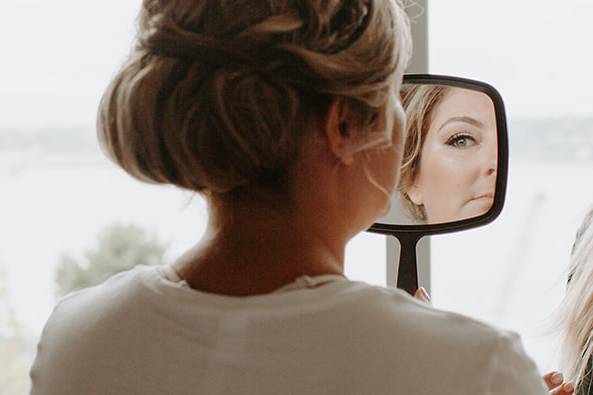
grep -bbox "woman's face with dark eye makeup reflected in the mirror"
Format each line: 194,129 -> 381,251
408,88 -> 497,223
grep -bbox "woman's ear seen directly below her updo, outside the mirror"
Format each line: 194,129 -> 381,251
323,98 -> 355,166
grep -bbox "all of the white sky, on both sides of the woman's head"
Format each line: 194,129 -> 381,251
0,0 -> 593,127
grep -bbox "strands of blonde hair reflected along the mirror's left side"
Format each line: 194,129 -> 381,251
398,85 -> 449,223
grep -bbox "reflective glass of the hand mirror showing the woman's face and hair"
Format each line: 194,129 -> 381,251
378,82 -> 498,225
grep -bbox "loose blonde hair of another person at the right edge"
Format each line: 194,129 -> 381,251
558,209 -> 593,394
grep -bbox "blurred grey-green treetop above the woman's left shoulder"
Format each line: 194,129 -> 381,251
55,223 -> 167,296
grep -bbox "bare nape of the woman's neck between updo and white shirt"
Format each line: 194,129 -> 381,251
174,198 -> 347,296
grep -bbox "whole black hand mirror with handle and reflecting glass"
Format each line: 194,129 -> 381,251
368,74 -> 508,294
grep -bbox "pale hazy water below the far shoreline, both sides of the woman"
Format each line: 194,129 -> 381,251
0,148 -> 593,370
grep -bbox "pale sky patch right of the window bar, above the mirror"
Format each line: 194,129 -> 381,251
428,0 -> 593,118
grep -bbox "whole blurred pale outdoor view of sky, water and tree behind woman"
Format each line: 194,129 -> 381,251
0,0 -> 593,395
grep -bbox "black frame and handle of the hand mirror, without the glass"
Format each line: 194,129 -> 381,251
367,74 -> 509,295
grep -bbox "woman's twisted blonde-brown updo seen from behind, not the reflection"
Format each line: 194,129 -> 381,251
98,0 -> 411,193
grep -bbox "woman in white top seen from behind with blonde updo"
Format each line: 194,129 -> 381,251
31,0 -> 564,395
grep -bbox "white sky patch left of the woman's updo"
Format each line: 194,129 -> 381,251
0,0 -> 140,127
